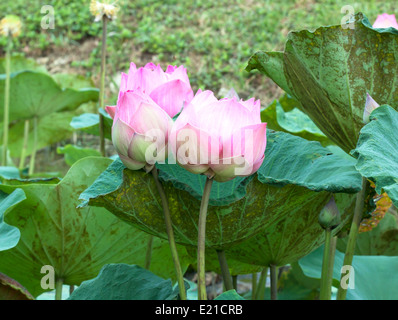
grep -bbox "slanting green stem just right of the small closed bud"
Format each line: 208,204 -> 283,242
336,177 -> 369,300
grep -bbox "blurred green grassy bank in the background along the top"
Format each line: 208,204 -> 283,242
0,0 -> 398,105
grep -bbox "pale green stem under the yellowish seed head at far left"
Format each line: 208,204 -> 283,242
1,35 -> 12,166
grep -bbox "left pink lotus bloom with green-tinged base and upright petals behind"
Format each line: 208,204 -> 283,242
105,63 -> 193,170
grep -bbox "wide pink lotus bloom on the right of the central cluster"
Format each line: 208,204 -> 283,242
169,90 -> 267,182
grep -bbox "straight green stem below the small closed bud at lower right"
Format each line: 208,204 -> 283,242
319,228 -> 336,300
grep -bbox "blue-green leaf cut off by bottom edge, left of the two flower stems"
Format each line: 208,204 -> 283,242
68,264 -> 178,300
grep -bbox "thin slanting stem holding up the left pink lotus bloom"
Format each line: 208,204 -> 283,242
151,167 -> 187,300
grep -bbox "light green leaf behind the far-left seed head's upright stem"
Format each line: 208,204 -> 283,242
0,71 -> 98,121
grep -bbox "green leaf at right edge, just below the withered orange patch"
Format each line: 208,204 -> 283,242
337,212 -> 398,256
